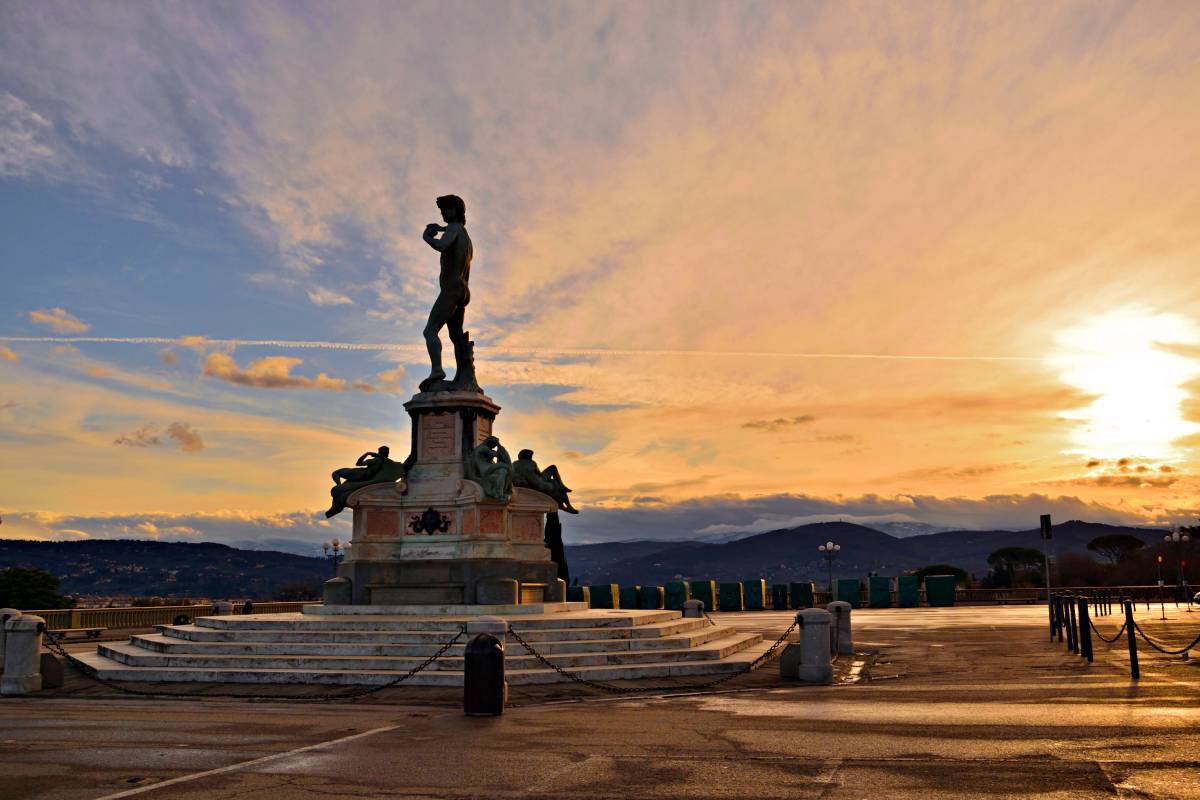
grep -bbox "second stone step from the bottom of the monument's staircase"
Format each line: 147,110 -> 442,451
97,631 -> 762,672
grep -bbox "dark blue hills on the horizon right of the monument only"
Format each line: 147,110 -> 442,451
566,521 -> 1162,584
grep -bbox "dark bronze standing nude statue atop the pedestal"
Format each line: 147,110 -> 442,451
420,194 -> 480,392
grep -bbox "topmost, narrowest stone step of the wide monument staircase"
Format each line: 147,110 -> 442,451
194,609 -> 686,632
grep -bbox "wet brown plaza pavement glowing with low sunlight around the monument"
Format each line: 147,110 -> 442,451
0,606 -> 1200,800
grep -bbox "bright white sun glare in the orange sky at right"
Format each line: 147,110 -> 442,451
1050,309 -> 1200,462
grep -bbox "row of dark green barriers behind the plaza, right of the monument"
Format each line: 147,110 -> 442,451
566,575 -> 955,612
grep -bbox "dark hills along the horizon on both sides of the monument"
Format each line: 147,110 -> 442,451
0,521 -> 1162,600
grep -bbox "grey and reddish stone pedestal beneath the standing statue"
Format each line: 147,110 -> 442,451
334,391 -> 558,606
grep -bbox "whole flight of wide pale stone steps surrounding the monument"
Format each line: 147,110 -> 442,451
75,603 -> 764,686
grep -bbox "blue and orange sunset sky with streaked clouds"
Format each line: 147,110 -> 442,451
0,0 -> 1200,552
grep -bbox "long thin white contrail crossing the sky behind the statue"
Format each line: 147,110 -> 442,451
0,336 -> 1044,361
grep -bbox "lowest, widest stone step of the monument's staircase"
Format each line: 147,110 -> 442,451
70,634 -> 767,702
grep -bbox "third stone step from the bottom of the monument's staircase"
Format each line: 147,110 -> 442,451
132,625 -> 736,657
